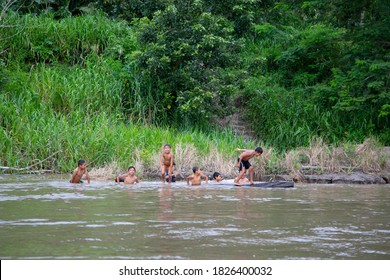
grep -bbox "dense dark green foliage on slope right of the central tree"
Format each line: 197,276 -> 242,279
242,1 -> 390,147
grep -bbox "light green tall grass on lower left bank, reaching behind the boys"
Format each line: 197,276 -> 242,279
0,52 -> 257,176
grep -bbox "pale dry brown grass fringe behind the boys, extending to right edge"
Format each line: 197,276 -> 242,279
90,139 -> 388,182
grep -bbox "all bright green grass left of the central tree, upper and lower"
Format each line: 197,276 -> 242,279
0,10 -> 248,171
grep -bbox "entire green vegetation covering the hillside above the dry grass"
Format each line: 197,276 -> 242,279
0,0 -> 390,173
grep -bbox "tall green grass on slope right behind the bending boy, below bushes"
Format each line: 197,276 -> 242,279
241,71 -> 370,151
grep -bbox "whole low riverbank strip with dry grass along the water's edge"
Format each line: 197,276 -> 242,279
2,139 -> 390,184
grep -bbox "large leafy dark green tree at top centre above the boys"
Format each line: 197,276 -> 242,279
135,0 -> 244,124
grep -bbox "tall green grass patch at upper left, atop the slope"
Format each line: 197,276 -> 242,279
0,11 -> 136,66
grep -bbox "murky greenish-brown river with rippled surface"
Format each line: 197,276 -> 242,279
0,176 -> 390,259
